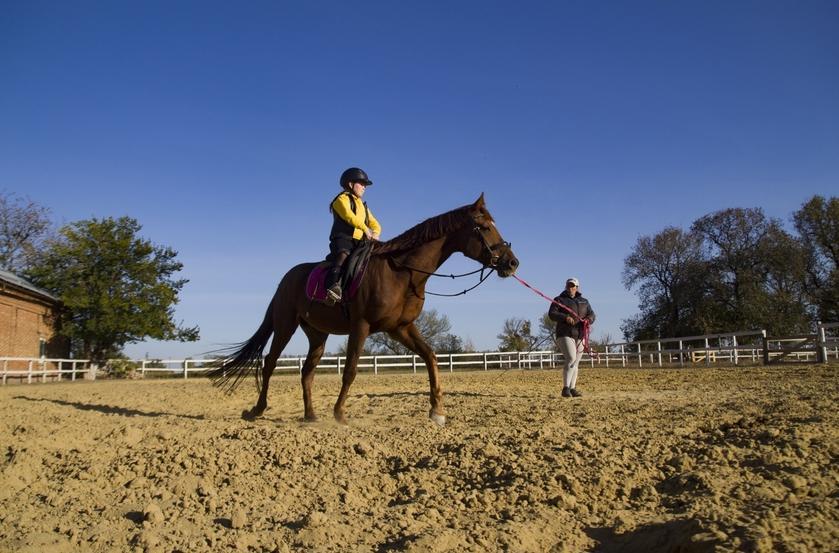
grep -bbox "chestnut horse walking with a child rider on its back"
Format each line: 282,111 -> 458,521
208,194 -> 518,426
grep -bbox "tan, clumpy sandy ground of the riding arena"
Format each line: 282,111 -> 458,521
0,365 -> 839,553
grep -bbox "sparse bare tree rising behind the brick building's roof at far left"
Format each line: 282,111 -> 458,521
0,192 -> 51,273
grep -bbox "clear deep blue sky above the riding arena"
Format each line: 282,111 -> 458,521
0,1 -> 839,357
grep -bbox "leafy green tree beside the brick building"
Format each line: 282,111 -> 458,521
27,217 -> 198,363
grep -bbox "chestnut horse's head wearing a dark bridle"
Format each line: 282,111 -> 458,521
461,194 -> 519,277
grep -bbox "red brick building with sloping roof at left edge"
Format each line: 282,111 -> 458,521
0,270 -> 70,358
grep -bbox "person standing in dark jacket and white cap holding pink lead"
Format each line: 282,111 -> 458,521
548,277 -> 595,397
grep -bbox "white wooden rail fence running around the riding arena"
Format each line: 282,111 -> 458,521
0,323 -> 839,384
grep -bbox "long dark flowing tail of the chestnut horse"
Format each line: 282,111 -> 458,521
204,300 -> 274,393
